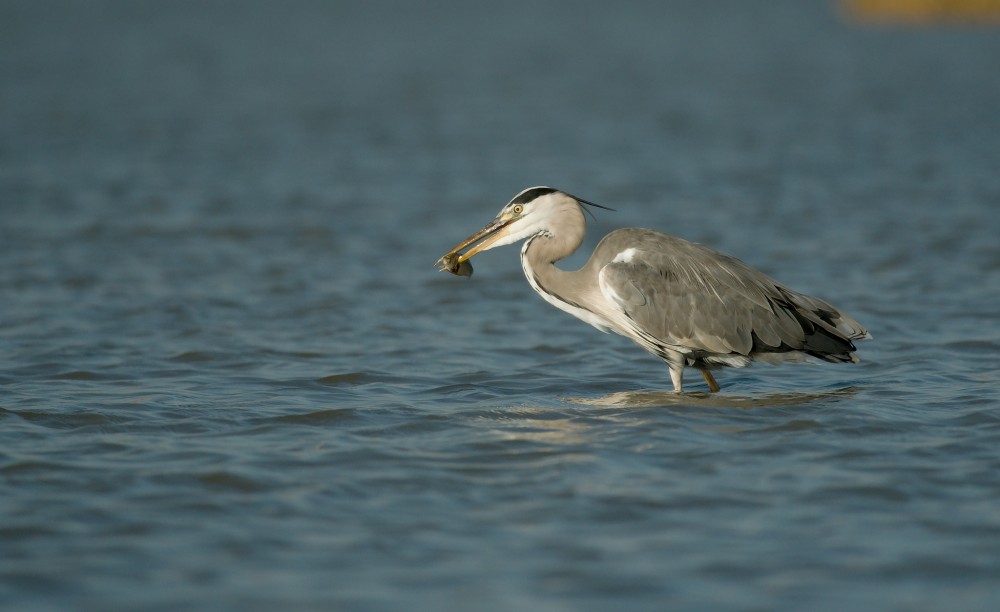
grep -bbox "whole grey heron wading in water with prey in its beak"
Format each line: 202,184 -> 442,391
438,187 -> 871,392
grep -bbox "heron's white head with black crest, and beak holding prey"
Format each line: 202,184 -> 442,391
438,187 -> 605,263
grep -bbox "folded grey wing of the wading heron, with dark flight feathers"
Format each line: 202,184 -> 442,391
598,230 -> 867,355
